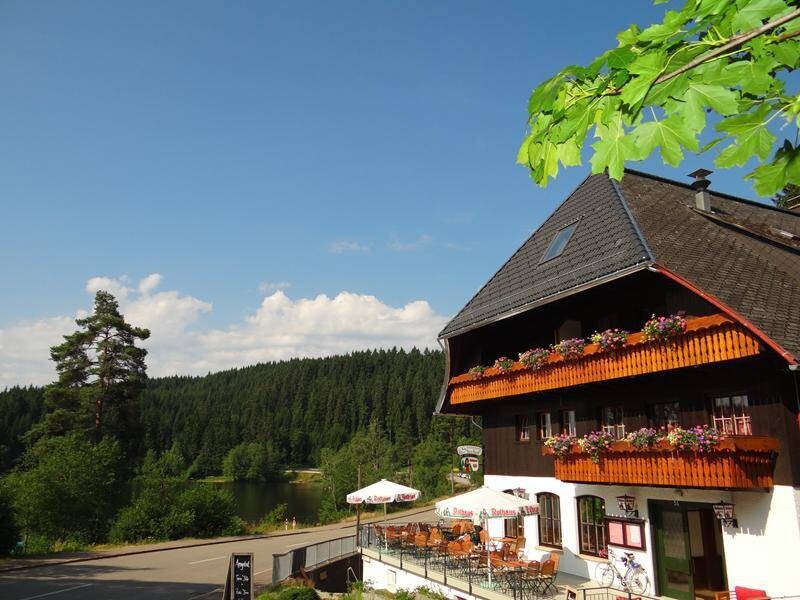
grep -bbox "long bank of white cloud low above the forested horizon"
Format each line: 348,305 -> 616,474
0,274 -> 447,387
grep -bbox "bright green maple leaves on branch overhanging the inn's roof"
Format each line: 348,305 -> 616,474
517,0 -> 800,196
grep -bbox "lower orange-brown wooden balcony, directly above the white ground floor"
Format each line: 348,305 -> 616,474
542,435 -> 778,490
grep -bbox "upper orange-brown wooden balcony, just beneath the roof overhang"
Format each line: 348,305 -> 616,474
448,314 -> 762,404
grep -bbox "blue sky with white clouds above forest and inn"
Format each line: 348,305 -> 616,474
0,0 -> 776,389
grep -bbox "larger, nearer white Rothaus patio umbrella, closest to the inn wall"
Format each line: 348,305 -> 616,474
436,486 -> 539,585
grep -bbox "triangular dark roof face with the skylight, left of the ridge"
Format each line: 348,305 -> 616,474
439,175 -> 650,337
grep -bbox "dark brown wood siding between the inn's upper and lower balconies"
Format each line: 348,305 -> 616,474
475,357 -> 800,486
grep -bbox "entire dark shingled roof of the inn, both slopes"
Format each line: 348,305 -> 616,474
440,171 -> 800,358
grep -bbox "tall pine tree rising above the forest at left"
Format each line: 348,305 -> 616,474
31,291 -> 150,447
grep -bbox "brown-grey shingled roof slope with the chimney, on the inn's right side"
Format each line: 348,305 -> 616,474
619,172 -> 800,358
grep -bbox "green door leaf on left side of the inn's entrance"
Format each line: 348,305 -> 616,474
651,504 -> 694,600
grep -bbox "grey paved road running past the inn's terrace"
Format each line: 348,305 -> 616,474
0,511 -> 433,600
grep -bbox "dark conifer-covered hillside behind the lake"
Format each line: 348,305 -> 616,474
0,349 -> 444,476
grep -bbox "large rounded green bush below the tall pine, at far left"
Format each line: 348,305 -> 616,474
7,434 -> 121,542
